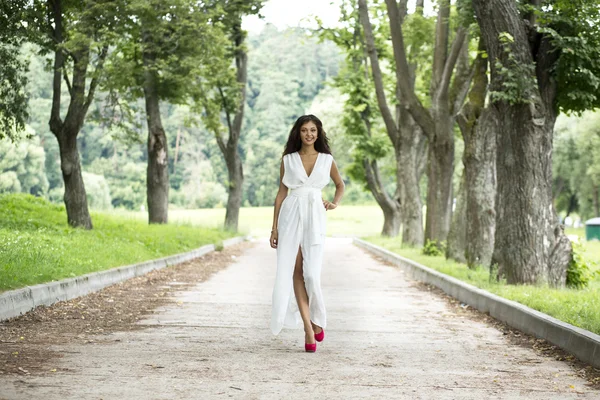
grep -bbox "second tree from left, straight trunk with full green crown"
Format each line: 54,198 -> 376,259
105,0 -> 225,223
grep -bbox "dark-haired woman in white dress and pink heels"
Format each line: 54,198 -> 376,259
270,115 -> 344,352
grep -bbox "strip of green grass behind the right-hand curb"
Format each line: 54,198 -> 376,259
365,237 -> 600,334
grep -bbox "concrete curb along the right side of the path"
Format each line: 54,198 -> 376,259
353,238 -> 600,368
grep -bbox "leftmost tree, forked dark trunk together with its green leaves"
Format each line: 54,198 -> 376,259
27,0 -> 116,229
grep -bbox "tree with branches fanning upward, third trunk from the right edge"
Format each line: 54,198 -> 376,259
359,0 -> 467,242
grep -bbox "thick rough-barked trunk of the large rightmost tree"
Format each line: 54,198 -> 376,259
473,0 -> 572,286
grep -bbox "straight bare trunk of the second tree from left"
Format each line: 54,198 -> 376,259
142,38 -> 169,224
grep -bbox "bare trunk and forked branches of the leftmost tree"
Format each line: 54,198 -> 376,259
48,0 -> 108,229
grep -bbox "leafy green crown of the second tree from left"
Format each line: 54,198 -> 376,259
100,0 -> 229,137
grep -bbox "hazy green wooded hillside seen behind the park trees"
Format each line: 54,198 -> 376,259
0,25 -> 600,225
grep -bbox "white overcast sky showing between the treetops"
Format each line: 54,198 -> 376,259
243,0 -> 431,33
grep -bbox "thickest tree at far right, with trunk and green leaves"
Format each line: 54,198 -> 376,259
473,0 -> 600,286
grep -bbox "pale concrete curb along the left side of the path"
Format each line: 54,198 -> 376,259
0,236 -> 249,321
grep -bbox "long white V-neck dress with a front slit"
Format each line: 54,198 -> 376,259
271,152 -> 333,335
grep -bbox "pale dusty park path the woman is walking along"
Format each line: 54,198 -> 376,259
0,238 -> 600,400
